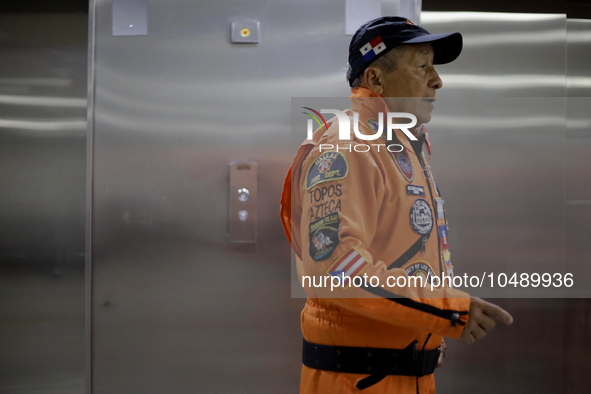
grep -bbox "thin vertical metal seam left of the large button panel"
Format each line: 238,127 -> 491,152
84,0 -> 96,394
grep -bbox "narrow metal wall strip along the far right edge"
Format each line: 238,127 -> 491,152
562,19 -> 591,393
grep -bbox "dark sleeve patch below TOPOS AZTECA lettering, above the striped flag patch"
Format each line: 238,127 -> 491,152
309,212 -> 341,261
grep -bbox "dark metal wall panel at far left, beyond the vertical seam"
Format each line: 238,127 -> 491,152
0,14 -> 88,394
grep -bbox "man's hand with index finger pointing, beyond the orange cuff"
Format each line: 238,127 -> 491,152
460,297 -> 513,345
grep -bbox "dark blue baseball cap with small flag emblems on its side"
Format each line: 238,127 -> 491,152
349,16 -> 463,85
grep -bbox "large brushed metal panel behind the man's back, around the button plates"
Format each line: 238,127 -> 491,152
92,0 -> 350,394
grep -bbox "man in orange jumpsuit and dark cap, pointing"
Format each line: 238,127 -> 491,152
281,17 -> 512,394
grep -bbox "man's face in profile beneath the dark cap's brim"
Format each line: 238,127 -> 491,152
382,43 -> 443,126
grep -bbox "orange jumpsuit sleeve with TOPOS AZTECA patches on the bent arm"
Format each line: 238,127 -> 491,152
291,145 -> 470,338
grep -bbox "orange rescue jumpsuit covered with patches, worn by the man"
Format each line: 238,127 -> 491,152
281,88 -> 470,394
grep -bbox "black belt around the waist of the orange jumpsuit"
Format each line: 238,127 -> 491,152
302,339 -> 441,390
